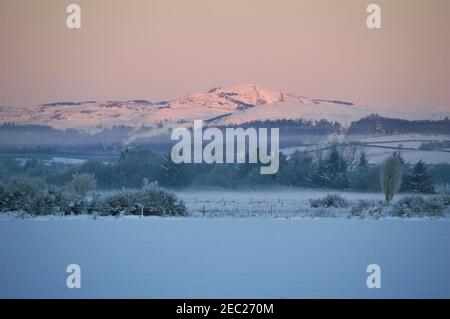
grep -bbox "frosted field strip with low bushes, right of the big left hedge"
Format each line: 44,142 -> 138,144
178,189 -> 450,219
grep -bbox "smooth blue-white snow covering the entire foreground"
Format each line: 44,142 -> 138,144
0,216 -> 450,298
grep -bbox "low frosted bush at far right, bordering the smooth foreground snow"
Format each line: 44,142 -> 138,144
391,196 -> 447,217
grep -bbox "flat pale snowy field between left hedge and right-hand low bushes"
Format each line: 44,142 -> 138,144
177,187 -> 427,218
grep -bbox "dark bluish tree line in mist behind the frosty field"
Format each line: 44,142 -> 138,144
0,143 -> 442,193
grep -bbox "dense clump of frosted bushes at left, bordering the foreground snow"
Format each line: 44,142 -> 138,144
0,173 -> 186,216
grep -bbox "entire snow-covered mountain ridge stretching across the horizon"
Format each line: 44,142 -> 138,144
0,84 -> 450,135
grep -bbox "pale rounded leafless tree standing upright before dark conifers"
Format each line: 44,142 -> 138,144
380,154 -> 403,203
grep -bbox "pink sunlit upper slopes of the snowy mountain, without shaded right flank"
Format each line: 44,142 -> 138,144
0,84 -> 334,131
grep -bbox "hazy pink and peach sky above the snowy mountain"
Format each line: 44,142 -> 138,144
0,0 -> 450,111
